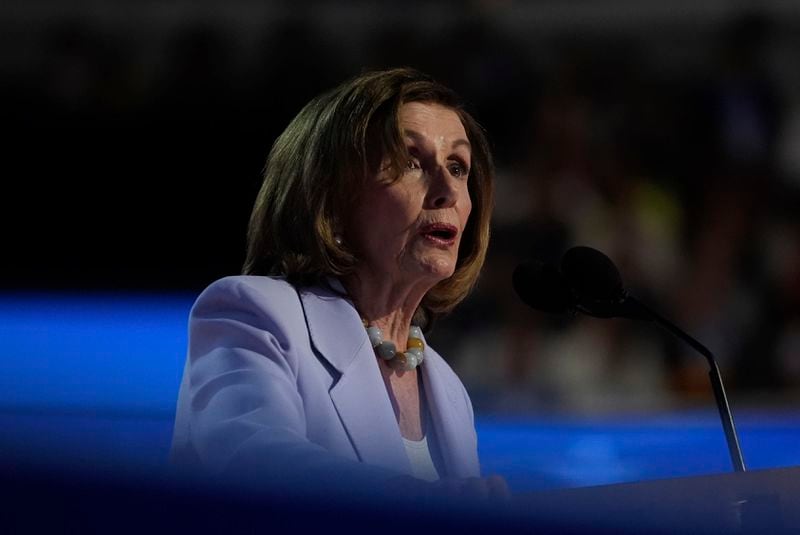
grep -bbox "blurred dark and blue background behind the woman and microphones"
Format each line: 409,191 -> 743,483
0,0 -> 800,489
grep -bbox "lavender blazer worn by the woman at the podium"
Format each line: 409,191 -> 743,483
172,276 -> 480,490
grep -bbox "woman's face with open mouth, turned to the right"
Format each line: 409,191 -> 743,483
345,102 -> 472,285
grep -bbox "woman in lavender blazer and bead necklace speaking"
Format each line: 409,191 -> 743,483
173,69 -> 507,495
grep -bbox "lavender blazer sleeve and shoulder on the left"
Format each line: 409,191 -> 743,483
173,278 -> 400,489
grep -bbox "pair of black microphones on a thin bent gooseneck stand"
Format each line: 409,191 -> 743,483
512,246 -> 745,472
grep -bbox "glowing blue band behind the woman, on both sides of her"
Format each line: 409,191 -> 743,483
0,294 -> 800,491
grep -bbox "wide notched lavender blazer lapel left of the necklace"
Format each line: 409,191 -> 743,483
299,287 -> 411,473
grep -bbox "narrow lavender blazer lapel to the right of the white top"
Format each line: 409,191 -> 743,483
421,347 -> 480,477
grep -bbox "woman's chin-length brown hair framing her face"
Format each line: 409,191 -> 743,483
243,68 -> 494,323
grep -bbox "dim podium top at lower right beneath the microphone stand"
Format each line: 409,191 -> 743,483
515,467 -> 800,534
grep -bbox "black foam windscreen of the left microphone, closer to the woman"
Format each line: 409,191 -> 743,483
511,260 -> 575,314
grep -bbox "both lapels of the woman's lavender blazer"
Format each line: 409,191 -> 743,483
299,281 -> 475,477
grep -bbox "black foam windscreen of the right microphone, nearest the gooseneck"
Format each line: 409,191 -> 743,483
561,247 -> 624,302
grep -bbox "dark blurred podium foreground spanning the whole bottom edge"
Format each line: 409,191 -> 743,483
6,463 -> 800,535
